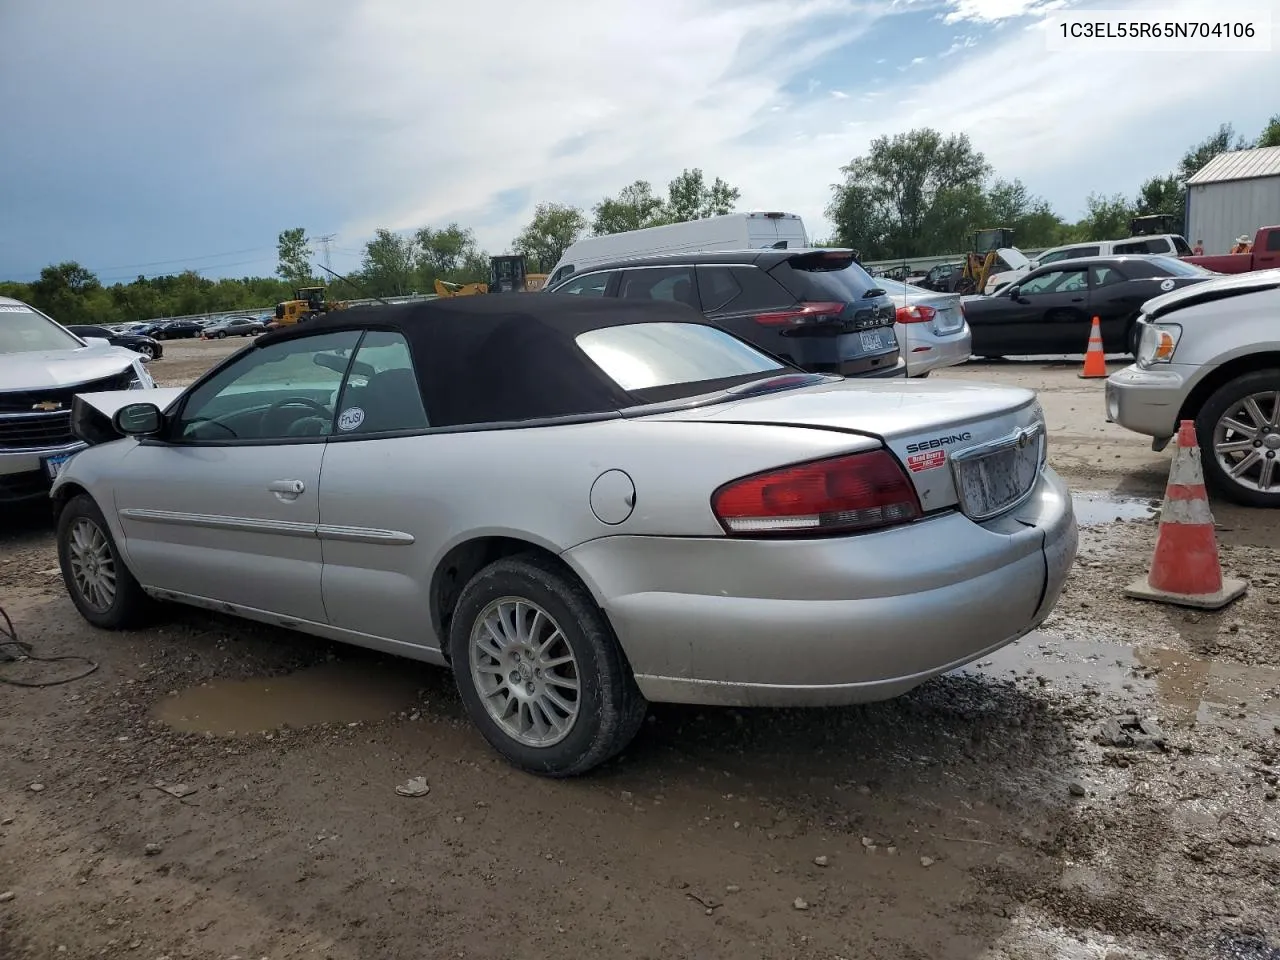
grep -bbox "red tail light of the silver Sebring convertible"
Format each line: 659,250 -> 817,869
712,451 -> 922,536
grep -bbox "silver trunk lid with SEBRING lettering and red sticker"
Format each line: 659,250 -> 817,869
648,380 -> 1044,520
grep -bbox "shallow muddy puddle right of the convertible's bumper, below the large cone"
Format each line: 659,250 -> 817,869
968,634 -> 1280,735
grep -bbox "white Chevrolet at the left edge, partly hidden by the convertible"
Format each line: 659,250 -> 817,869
0,297 -> 155,506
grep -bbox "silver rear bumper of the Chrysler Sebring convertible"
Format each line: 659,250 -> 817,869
564,470 -> 1076,707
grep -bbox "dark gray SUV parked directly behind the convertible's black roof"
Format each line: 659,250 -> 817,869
549,250 -> 906,376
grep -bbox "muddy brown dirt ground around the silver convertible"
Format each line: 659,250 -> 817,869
0,343 -> 1280,960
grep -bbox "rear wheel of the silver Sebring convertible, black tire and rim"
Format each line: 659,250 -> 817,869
449,554 -> 648,777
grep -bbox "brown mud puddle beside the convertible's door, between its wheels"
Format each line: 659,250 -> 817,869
152,660 -> 421,736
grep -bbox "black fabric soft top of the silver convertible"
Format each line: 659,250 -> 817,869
256,293 -> 732,426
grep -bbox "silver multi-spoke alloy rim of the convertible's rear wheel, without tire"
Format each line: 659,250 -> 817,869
470,596 -> 581,746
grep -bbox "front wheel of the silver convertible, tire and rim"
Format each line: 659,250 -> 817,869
58,493 -> 150,630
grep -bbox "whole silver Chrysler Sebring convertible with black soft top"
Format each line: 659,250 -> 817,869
52,293 -> 1076,776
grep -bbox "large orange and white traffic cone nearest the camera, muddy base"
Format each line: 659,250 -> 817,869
1124,420 -> 1248,611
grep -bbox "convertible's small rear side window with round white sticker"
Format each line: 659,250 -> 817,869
337,330 -> 430,436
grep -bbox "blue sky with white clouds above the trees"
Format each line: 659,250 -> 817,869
0,0 -> 1280,283
